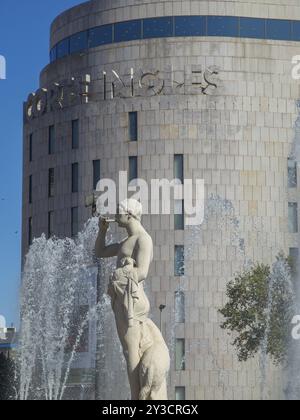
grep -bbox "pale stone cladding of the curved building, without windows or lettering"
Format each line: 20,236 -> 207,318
22,0 -> 300,400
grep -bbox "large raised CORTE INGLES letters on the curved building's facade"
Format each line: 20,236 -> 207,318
24,66 -> 219,122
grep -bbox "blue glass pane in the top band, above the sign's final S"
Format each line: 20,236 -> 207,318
207,16 -> 239,37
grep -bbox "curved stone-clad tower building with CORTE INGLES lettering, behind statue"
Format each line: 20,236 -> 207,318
22,0 -> 300,400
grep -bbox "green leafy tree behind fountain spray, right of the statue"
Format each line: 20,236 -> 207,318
220,254 -> 294,364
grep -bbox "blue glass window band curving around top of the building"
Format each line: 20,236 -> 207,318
50,15 -> 300,63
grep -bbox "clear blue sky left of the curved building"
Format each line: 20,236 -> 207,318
0,0 -> 82,324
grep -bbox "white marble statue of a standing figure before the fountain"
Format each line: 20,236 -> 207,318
95,199 -> 170,400
